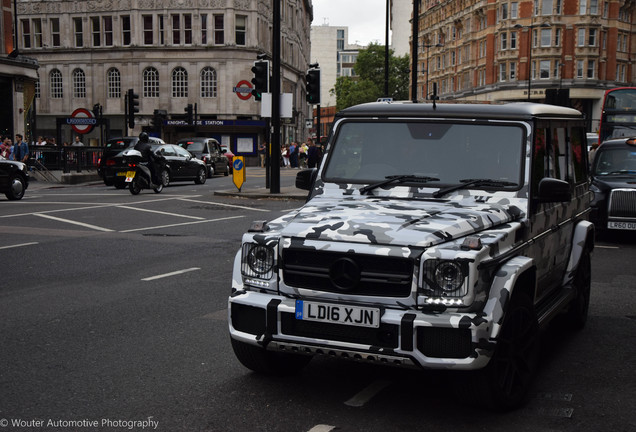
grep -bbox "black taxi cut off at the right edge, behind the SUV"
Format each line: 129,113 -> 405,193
590,137 -> 636,230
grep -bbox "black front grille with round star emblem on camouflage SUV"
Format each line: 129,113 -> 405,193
283,249 -> 413,297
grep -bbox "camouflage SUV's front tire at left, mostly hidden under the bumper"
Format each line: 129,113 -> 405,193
231,339 -> 312,375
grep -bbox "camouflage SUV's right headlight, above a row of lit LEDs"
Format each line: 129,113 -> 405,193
422,259 -> 468,306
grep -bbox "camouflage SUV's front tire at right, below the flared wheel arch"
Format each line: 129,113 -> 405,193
456,292 -> 540,411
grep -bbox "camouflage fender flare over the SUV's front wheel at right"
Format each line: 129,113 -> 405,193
483,256 -> 534,340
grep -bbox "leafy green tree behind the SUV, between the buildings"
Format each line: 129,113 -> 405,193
331,43 -> 410,110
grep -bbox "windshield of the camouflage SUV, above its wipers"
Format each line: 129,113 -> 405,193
324,120 -> 525,187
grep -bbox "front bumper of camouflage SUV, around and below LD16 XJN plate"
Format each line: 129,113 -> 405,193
228,291 -> 495,370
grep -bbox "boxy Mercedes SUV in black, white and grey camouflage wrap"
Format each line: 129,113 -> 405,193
228,103 -> 594,409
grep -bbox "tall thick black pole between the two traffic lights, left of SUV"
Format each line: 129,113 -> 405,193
269,1 -> 280,193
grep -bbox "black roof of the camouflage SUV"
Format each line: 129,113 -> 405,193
337,102 -> 584,120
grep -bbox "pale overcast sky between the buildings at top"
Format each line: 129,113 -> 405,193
311,0 -> 386,45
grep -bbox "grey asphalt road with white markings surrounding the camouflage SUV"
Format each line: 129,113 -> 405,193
0,172 -> 636,432
